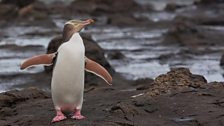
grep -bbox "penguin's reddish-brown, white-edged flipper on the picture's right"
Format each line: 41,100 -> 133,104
85,57 -> 112,85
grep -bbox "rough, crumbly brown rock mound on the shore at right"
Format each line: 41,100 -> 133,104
148,68 -> 207,96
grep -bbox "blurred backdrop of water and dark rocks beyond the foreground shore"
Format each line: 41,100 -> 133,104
0,0 -> 224,92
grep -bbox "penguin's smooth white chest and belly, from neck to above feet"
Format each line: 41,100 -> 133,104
51,33 -> 85,107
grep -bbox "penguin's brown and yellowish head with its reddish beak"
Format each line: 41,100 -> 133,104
63,19 -> 94,42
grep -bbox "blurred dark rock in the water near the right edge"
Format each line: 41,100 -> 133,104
164,17 -> 224,49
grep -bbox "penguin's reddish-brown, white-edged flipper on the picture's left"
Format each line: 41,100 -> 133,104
20,53 -> 57,70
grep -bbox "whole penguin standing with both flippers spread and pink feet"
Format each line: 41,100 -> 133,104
20,19 -> 112,122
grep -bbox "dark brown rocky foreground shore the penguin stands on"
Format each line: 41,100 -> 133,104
0,68 -> 224,126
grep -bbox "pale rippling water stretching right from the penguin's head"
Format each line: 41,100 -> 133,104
86,27 -> 224,82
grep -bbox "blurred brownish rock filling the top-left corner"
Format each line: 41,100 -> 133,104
0,0 -> 55,27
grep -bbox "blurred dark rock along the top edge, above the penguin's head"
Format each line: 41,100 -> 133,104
70,0 -> 141,15
